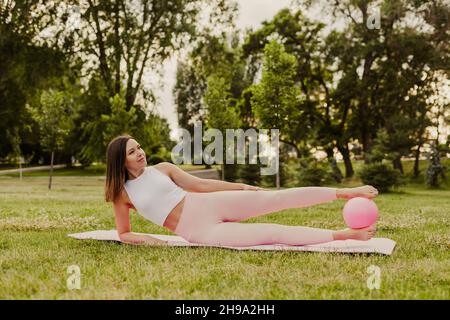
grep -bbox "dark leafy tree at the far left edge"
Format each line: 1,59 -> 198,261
0,0 -> 76,162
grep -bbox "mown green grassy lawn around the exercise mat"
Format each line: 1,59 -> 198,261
0,160 -> 450,299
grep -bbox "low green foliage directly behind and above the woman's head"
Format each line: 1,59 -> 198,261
71,81 -> 174,165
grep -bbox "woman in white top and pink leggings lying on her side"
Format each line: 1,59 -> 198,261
105,135 -> 378,246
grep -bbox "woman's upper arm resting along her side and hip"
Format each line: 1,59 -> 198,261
155,162 -> 264,192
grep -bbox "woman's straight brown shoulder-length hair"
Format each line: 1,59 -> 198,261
105,134 -> 134,202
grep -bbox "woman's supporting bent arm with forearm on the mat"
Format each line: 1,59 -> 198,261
113,201 -> 167,245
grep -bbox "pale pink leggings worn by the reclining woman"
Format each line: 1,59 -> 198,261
175,187 -> 337,246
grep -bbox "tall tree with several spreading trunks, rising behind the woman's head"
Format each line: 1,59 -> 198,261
55,0 -> 234,162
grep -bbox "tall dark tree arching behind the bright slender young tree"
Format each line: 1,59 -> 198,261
243,8 -> 353,176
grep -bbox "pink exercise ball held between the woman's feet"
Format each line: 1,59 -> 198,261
342,197 -> 378,229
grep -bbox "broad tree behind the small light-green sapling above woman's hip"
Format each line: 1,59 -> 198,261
174,30 -> 251,175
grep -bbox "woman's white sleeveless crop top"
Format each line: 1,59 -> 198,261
125,166 -> 187,226
